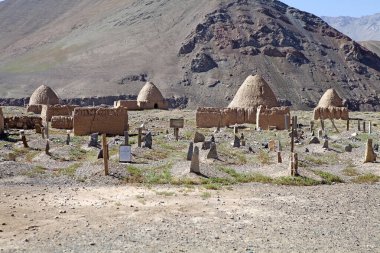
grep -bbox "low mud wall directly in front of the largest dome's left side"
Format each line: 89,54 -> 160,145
196,107 -> 256,128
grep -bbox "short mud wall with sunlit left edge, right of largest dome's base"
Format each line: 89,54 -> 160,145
256,106 -> 290,130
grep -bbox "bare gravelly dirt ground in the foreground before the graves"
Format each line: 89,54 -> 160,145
0,184 -> 380,252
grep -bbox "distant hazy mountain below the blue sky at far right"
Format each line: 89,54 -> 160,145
322,13 -> 380,41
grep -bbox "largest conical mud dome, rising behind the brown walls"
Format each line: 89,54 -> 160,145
228,75 -> 279,108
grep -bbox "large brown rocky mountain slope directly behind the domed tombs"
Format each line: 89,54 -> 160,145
0,0 -> 380,110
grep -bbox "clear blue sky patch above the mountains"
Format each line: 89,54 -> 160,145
280,0 -> 380,17
